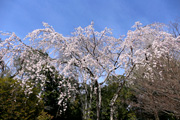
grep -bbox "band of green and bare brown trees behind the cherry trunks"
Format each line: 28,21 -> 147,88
0,61 -> 180,120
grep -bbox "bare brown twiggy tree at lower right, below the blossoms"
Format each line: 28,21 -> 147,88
133,54 -> 180,120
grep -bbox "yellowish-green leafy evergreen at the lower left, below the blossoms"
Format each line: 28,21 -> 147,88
0,78 -> 43,120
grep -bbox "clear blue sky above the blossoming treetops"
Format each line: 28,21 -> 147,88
0,0 -> 180,38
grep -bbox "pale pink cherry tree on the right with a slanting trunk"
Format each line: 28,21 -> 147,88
111,22 -> 180,120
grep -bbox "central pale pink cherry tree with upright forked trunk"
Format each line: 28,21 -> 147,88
21,23 -> 132,119
